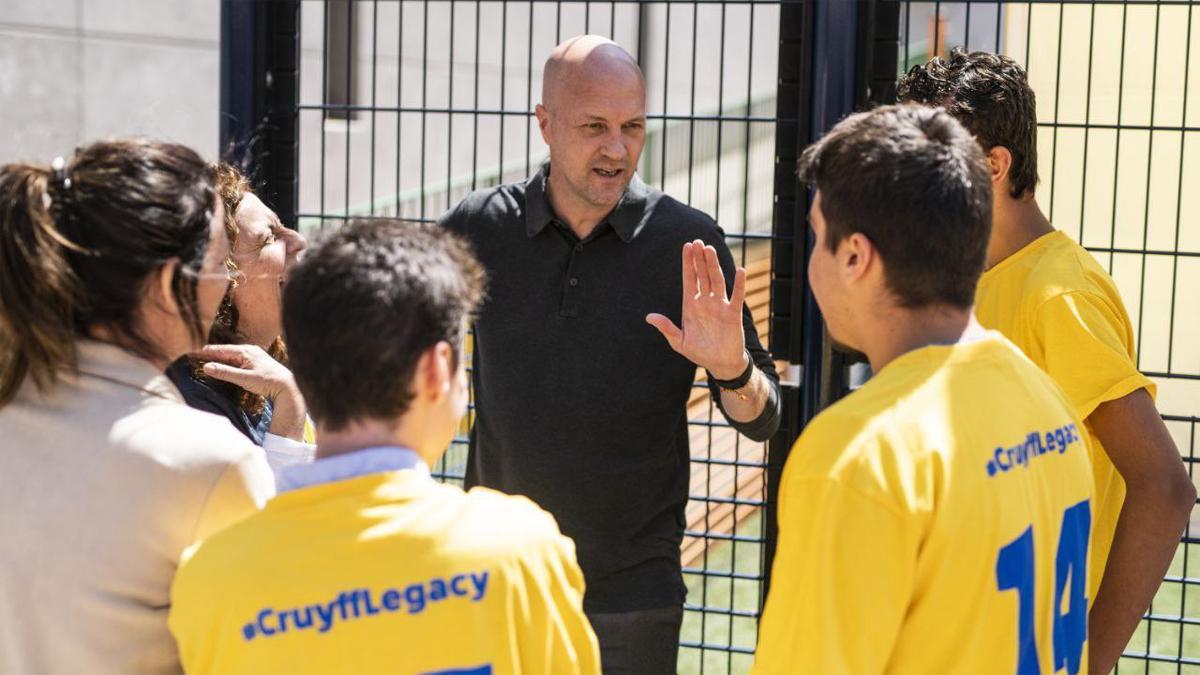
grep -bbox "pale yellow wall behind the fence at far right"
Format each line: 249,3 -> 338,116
1004,4 -> 1200,422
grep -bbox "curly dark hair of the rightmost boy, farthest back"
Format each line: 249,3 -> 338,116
896,47 -> 1038,198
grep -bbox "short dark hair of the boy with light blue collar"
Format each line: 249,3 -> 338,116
283,220 -> 485,430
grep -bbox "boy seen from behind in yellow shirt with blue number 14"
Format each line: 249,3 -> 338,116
754,106 -> 1092,675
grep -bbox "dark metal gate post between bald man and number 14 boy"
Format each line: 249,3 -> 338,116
763,0 -> 900,593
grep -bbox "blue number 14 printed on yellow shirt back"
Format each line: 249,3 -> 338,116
996,500 -> 1092,675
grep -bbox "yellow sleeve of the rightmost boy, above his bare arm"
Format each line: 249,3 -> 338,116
1034,291 -> 1154,419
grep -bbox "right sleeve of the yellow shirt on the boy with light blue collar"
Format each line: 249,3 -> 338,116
516,534 -> 600,675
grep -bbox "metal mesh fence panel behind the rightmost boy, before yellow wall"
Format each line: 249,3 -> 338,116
899,0 -> 1200,673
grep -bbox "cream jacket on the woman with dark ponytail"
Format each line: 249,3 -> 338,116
0,340 -> 274,674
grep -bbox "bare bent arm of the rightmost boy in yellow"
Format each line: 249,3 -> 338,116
1087,389 -> 1196,673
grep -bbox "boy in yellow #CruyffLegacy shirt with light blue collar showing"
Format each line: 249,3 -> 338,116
169,221 -> 600,675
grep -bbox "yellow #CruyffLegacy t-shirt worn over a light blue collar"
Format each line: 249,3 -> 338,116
169,470 -> 600,675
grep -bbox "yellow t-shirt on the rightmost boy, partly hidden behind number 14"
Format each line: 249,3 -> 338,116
976,231 -> 1156,597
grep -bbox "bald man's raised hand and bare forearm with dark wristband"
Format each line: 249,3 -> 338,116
646,239 -> 780,441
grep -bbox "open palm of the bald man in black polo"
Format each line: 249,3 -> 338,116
646,239 -> 746,380
